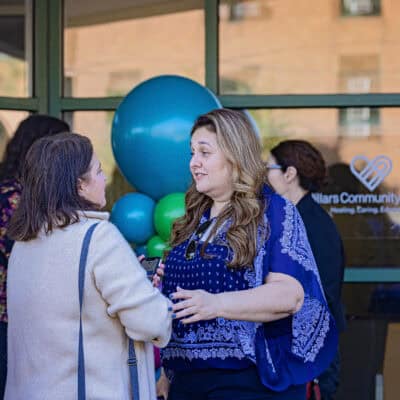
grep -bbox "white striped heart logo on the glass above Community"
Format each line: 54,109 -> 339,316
350,155 -> 392,192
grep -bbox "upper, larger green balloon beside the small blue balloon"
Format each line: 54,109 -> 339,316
154,193 -> 185,241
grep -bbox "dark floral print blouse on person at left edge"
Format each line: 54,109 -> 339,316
0,179 -> 21,322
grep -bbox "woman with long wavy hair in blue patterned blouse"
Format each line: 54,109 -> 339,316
162,109 -> 337,400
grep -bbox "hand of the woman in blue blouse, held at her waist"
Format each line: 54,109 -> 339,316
170,287 -> 219,324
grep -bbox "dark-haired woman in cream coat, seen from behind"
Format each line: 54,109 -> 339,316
5,133 -> 171,400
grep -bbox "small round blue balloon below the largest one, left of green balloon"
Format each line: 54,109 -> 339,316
110,193 -> 156,244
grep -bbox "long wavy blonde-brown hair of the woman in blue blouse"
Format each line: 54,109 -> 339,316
171,109 -> 266,268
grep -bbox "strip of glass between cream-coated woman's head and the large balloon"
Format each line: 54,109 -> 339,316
64,111 -> 135,210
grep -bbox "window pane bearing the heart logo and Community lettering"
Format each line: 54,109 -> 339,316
255,108 -> 400,267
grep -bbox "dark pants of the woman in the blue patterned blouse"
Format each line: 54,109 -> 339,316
168,367 -> 306,400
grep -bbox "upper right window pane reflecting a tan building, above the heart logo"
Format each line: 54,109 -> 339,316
219,0 -> 400,94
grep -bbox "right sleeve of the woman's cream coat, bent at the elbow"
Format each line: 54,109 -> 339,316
88,222 -> 172,347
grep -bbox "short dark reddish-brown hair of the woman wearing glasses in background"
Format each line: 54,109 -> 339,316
271,140 -> 326,192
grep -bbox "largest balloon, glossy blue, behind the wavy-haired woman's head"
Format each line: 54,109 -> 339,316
112,75 -> 221,200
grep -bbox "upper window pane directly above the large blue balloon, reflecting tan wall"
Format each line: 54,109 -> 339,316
64,0 -> 204,97
